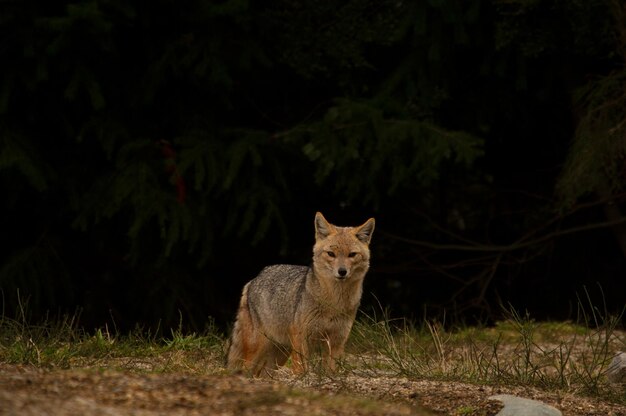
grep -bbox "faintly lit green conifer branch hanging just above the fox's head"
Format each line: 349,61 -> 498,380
287,100 -> 483,206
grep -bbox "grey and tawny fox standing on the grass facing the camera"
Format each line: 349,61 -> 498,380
227,212 -> 375,377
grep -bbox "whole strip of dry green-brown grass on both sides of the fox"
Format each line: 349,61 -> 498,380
0,294 -> 626,404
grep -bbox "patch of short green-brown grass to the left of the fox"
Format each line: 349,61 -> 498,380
0,300 -> 224,372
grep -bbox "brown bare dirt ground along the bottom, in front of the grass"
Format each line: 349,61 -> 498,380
0,364 -> 626,416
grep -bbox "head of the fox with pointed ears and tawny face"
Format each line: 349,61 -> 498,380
313,212 -> 374,280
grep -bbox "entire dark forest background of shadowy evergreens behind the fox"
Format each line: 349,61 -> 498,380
0,0 -> 626,329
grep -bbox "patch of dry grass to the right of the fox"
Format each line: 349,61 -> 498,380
344,300 -> 626,404
